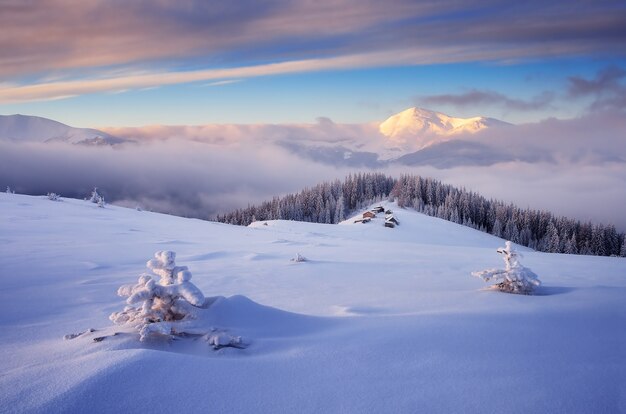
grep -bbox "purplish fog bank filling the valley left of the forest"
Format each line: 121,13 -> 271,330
0,141 -> 343,218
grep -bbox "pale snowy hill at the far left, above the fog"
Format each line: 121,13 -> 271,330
0,115 -> 127,145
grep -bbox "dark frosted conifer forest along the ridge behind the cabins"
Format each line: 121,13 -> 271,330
217,173 -> 626,257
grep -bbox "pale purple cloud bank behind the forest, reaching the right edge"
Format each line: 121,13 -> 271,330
389,111 -> 626,231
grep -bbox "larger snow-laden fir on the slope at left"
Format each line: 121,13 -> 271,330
109,251 -> 205,341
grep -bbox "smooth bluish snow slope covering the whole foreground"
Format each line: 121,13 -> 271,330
0,194 -> 626,413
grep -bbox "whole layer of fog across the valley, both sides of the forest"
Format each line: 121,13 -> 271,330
0,113 -> 626,230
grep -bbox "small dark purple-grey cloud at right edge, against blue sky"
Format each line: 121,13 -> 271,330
567,66 -> 626,111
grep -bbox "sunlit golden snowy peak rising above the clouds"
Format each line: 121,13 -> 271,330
379,108 -> 510,149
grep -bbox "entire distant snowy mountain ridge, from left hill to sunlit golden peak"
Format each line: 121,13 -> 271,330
0,108 -> 514,168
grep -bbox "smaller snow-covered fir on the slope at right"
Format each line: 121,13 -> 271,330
472,241 -> 541,295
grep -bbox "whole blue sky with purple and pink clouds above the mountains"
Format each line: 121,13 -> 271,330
0,0 -> 626,127
